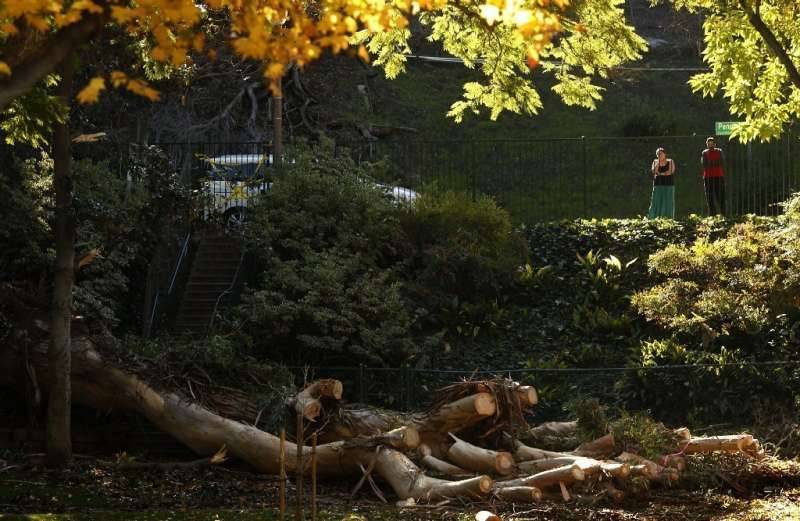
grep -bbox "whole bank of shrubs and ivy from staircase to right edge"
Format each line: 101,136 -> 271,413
194,141 -> 800,434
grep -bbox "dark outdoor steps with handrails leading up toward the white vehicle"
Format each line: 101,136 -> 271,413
175,230 -> 242,335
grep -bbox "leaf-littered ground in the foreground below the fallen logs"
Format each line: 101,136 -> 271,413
0,450 -> 800,521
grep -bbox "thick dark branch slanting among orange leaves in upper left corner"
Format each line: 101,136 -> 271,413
0,14 -> 106,110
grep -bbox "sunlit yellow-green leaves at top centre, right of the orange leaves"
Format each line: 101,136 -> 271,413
357,0 -> 646,122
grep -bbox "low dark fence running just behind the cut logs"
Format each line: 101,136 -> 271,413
290,361 -> 800,423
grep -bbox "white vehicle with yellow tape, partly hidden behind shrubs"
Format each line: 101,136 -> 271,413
203,154 -> 418,228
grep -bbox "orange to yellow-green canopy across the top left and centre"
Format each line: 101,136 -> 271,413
0,0 -> 645,120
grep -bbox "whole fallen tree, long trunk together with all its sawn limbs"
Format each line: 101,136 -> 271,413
0,312 -> 760,503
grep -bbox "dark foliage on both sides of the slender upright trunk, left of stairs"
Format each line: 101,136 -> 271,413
0,144 -> 187,329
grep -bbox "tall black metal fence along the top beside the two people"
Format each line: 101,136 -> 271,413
152,132 -> 800,222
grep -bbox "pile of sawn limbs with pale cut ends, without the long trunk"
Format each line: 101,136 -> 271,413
276,379 -> 760,505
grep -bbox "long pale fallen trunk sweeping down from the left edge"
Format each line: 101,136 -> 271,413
0,338 -> 493,499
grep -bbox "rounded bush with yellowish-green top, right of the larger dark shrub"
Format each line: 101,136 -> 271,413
402,190 -> 527,336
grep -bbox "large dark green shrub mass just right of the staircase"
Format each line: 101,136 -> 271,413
220,143 -> 525,366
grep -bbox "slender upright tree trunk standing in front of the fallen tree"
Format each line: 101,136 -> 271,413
47,56 -> 75,467
